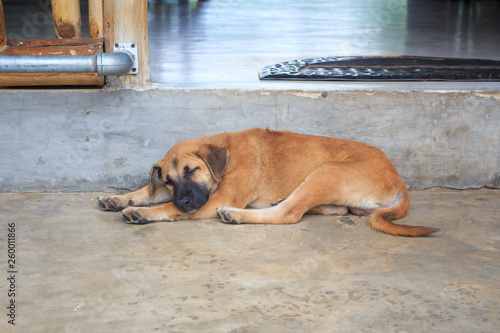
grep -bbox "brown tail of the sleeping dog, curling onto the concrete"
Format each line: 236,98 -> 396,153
368,188 -> 439,237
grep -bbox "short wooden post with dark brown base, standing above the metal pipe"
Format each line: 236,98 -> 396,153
52,0 -> 82,38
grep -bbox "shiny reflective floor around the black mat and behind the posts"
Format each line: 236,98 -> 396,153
4,0 -> 500,89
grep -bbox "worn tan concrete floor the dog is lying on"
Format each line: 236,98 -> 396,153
0,189 -> 500,333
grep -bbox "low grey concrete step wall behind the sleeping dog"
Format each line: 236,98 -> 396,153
0,89 -> 500,192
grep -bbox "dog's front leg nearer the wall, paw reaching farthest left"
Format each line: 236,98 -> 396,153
96,185 -> 172,211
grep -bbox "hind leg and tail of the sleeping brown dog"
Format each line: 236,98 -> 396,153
217,162 -> 437,237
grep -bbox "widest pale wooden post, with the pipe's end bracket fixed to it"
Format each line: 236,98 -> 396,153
104,0 -> 151,87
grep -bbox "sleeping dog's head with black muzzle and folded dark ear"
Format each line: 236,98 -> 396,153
149,141 -> 229,212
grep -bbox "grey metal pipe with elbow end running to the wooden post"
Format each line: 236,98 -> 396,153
0,51 -> 134,76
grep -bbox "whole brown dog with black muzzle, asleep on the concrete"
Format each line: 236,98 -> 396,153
97,129 -> 437,236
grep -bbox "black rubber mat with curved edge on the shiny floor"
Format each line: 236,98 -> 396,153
259,56 -> 500,81
